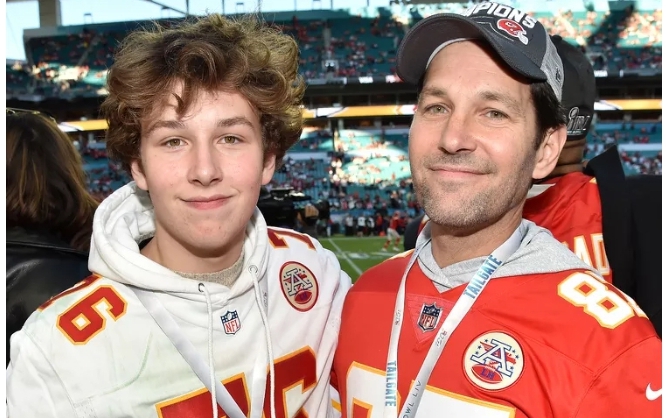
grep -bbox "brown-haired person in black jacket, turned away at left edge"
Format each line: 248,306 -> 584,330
6,108 -> 98,364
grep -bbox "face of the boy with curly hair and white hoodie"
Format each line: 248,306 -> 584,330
132,85 -> 275,272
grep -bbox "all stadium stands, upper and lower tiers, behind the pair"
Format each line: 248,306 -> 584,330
6,0 -> 662,232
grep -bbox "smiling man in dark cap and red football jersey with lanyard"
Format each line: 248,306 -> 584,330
334,3 -> 661,418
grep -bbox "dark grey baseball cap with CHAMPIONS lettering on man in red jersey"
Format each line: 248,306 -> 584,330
397,2 -> 564,100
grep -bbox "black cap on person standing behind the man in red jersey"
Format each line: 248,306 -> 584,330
551,35 -> 597,141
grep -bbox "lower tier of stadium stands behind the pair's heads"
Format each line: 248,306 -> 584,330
71,117 -> 662,217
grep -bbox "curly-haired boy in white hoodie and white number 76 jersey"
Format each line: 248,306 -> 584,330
7,15 -> 350,418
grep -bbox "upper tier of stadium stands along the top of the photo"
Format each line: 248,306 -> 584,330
7,4 -> 662,95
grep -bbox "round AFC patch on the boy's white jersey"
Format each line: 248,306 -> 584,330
280,261 -> 319,312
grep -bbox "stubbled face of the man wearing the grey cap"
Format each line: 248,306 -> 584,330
409,41 -> 536,232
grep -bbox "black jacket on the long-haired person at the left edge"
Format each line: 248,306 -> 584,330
7,228 -> 90,364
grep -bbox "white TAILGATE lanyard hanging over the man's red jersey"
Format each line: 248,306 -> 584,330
384,224 -> 524,418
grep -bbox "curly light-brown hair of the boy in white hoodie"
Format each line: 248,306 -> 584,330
101,14 -> 305,172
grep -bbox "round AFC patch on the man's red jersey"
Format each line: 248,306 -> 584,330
463,332 -> 525,390
